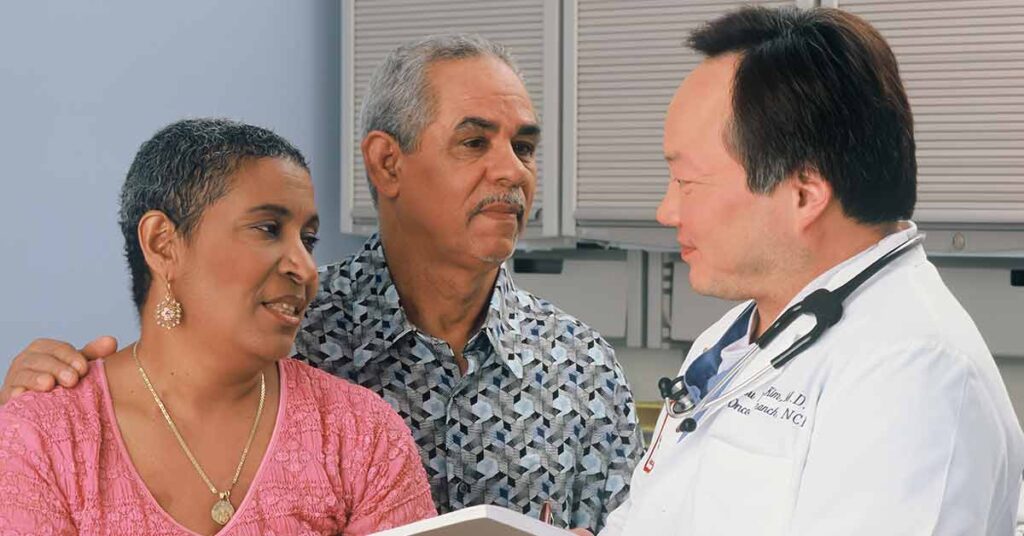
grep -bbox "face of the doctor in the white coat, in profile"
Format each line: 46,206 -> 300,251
657,54 -> 786,299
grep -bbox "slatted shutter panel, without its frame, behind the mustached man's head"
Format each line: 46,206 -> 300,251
342,0 -> 558,233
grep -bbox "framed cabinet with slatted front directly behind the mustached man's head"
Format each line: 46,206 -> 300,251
341,0 -> 561,237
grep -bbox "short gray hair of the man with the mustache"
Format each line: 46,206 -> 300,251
359,34 -> 523,205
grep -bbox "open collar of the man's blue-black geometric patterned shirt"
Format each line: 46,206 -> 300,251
355,233 -> 529,379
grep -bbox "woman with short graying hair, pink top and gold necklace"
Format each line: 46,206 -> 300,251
0,119 -> 435,534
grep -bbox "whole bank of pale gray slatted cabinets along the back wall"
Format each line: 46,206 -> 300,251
341,0 -> 1024,357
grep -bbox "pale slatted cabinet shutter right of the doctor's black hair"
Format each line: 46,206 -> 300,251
838,0 -> 1024,224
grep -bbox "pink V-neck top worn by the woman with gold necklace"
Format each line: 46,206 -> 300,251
0,360 -> 435,536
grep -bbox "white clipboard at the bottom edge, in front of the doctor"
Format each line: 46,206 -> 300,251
375,504 -> 572,536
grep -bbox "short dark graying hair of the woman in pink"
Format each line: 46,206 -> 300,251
119,119 -> 309,311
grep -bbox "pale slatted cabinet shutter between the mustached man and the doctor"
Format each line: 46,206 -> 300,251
566,0 -> 795,226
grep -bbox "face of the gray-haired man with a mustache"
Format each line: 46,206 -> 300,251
394,56 -> 540,265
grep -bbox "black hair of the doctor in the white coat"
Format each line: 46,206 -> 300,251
688,7 -> 918,223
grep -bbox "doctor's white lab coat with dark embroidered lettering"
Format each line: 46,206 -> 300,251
601,223 -> 1024,536
